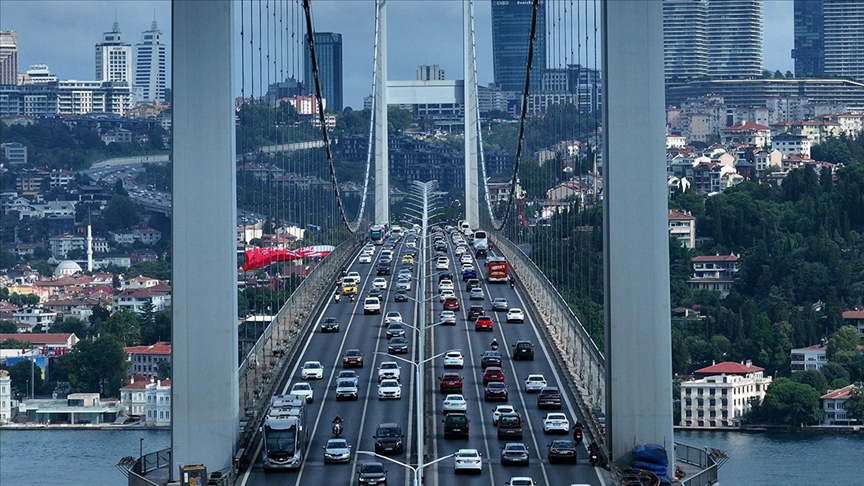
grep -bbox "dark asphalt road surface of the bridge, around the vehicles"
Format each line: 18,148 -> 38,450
241,231 -> 604,485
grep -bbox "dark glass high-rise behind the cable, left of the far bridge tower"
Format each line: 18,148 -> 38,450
304,32 -> 343,112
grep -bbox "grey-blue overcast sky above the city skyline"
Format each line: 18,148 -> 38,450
0,0 -> 793,108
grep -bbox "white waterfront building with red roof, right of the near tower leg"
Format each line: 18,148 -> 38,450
681,361 -> 771,427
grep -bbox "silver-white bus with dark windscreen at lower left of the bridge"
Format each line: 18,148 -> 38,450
262,395 -> 308,471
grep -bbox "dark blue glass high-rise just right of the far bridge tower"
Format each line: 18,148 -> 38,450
492,1 -> 546,92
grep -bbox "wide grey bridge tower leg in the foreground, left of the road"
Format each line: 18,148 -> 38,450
171,0 -> 240,480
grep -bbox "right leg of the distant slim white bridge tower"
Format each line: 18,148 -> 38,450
462,0 -> 480,228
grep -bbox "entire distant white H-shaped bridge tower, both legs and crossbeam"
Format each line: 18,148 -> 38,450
373,0 -> 480,227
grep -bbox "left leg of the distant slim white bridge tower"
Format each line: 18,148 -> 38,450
373,0 -> 390,223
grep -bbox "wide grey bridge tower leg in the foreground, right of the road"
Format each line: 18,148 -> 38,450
602,0 -> 674,467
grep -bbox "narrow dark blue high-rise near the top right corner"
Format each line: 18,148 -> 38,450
792,0 -> 825,76
